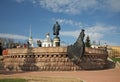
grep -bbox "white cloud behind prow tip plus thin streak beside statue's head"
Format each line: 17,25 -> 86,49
56,19 -> 116,41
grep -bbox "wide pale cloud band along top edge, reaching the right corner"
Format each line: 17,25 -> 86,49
16,0 -> 120,14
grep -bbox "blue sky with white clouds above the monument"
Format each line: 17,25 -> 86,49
0,0 -> 120,46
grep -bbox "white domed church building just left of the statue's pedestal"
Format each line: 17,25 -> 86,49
42,33 -> 53,47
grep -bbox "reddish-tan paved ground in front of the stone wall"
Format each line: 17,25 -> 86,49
0,68 -> 120,82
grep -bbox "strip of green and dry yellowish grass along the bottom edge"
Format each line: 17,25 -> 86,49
0,77 -> 84,82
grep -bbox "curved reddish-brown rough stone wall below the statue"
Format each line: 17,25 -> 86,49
4,47 -> 107,71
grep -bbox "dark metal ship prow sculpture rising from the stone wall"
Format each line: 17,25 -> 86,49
67,29 -> 85,62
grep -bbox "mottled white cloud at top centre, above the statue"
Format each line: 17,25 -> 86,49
39,0 -> 97,14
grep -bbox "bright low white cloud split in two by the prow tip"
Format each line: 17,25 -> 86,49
61,24 -> 116,40
